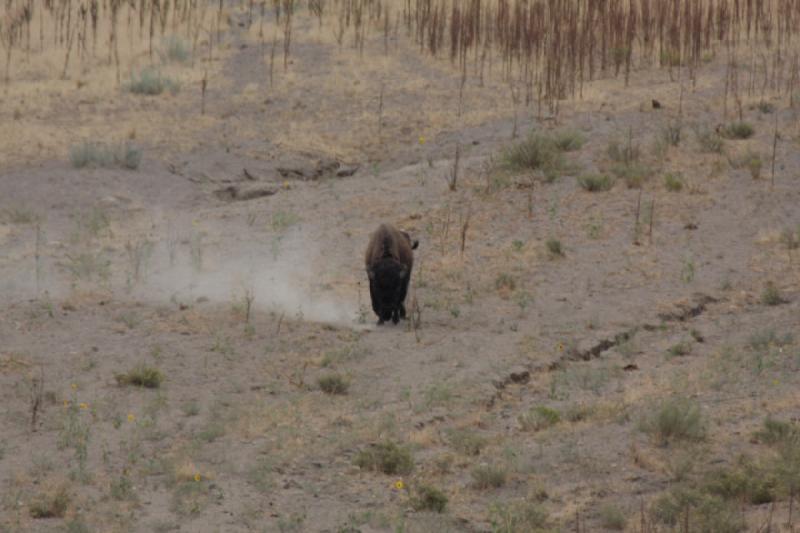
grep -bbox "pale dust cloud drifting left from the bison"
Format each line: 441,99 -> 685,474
0,213 -> 369,329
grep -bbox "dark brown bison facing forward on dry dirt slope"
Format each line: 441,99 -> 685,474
365,224 -> 419,325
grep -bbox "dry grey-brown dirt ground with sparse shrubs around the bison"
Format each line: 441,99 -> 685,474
0,1 -> 800,532
